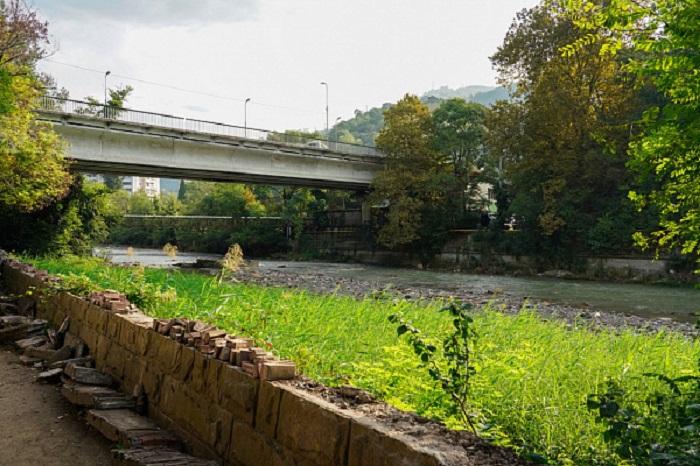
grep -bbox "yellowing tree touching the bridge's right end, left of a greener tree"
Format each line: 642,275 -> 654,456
370,94 -> 441,248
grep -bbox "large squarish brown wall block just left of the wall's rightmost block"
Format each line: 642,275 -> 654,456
277,387 -> 350,466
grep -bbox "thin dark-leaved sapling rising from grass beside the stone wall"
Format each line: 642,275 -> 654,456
389,300 -> 476,433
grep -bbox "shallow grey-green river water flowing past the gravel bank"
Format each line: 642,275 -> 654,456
102,248 -> 700,322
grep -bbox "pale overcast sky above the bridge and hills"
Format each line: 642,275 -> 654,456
30,0 -> 539,130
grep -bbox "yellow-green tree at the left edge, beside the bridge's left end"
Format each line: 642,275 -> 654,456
0,0 -> 71,212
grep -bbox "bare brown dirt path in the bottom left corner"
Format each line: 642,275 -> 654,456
0,348 -> 112,466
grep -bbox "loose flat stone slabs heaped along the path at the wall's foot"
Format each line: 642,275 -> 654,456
0,292 -> 216,466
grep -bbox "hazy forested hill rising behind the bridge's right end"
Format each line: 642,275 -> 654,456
330,86 -> 508,145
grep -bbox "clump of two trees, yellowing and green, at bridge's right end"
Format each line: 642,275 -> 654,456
370,95 -> 488,252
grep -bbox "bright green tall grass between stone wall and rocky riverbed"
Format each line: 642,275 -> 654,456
24,260 -> 700,465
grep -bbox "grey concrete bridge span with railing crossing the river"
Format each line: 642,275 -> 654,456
37,97 -> 384,190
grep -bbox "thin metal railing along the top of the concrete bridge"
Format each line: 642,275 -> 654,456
38,96 -> 381,157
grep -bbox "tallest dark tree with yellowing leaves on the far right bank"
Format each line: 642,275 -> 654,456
488,1 -> 639,265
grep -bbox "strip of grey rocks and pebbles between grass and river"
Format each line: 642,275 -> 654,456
180,258 -> 700,338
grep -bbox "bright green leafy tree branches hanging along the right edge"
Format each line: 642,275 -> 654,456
566,0 -> 700,266
